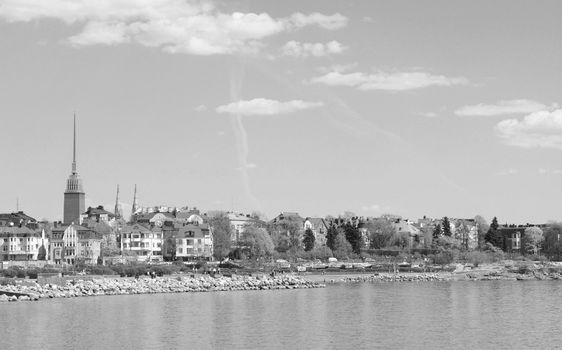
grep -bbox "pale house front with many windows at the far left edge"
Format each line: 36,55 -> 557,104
0,226 -> 49,261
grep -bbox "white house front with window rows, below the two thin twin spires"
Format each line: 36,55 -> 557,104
121,224 -> 162,260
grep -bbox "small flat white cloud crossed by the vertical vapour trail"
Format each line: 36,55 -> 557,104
216,98 -> 323,115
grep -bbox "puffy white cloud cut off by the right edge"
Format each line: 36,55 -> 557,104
495,109 -> 562,150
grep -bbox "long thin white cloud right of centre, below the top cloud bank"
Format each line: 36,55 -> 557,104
311,71 -> 469,91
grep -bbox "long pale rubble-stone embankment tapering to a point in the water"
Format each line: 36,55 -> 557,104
0,275 -> 325,301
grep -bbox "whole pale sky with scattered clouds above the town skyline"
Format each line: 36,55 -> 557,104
0,0 -> 562,223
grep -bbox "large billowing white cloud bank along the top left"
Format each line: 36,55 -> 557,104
0,0 -> 348,55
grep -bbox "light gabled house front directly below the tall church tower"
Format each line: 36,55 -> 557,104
49,224 -> 102,265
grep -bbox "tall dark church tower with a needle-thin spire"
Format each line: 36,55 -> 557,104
63,114 -> 86,224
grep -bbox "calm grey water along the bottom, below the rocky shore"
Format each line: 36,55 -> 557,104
0,281 -> 562,349
